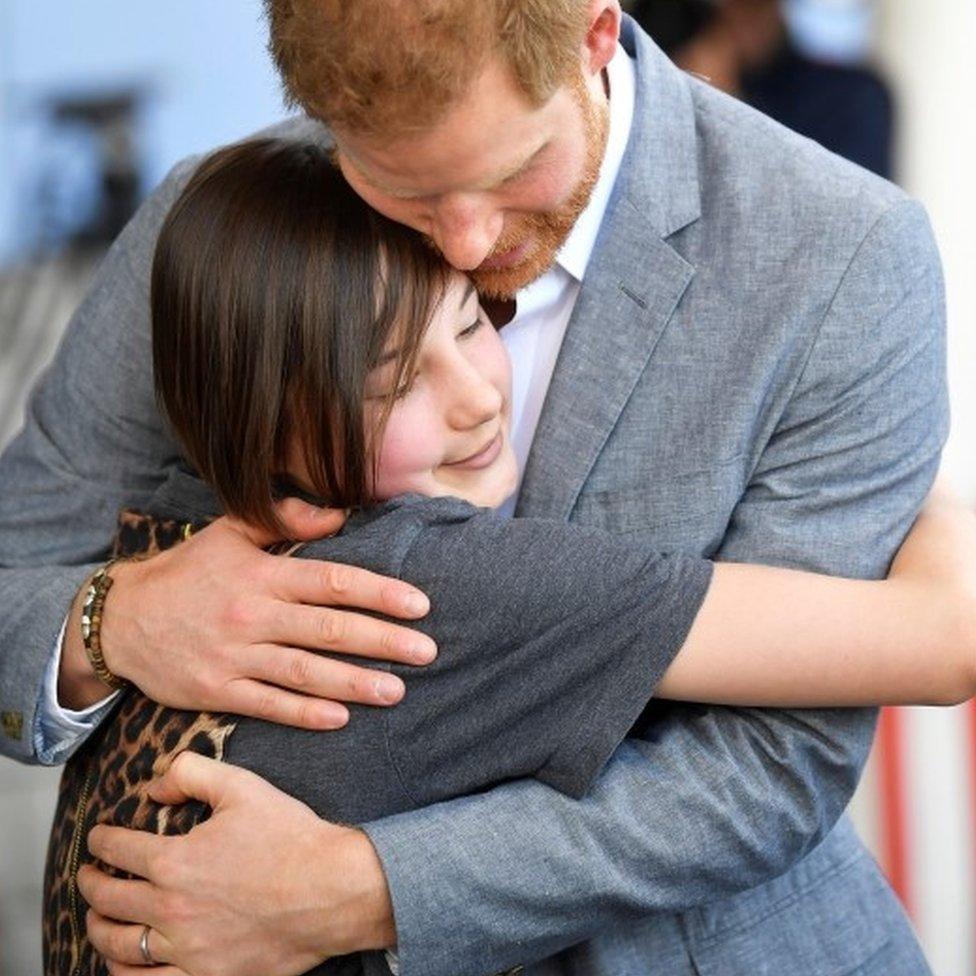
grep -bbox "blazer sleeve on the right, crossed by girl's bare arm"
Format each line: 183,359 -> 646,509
358,201 -> 948,976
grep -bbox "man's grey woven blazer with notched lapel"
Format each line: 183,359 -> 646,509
0,15 -> 947,976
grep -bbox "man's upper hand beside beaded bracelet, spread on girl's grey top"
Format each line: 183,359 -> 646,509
58,498 -> 436,729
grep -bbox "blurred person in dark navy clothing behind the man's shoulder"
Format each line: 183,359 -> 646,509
631,0 -> 894,178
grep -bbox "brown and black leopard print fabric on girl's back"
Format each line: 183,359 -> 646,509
43,512 -> 235,976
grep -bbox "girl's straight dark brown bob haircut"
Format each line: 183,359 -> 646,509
151,139 -> 448,532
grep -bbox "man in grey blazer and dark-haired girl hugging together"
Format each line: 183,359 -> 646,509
0,0 -> 976,974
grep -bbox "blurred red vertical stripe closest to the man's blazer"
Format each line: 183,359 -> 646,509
878,708 -> 912,915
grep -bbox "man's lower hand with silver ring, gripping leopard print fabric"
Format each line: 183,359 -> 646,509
78,753 -> 396,976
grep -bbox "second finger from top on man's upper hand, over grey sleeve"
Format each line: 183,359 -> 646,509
269,602 -> 437,668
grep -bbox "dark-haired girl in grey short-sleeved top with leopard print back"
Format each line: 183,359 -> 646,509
45,140 -> 976,973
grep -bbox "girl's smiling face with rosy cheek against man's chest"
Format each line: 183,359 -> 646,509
366,274 -> 518,507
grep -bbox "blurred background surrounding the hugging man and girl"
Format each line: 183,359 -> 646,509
0,0 -> 976,976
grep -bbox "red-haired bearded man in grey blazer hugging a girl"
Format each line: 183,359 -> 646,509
0,0 -> 946,976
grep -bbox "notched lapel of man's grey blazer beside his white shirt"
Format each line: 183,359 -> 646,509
516,20 -> 700,519
